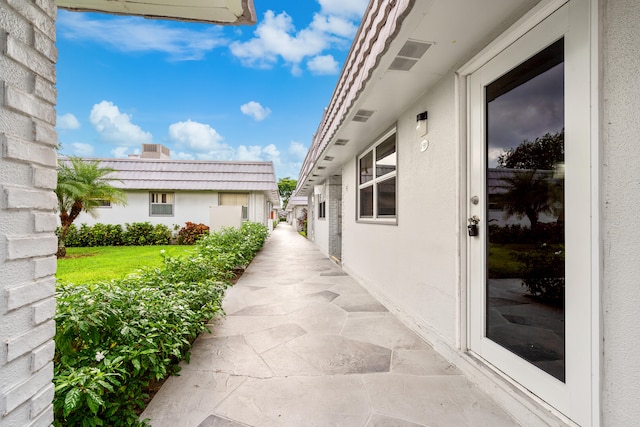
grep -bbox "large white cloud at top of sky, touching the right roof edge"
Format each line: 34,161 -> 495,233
230,0 -> 368,74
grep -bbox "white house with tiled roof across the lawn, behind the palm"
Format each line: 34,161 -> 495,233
65,145 -> 280,234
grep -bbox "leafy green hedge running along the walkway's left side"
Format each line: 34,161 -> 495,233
54,223 -> 268,426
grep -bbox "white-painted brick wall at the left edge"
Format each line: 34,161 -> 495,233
0,0 -> 57,427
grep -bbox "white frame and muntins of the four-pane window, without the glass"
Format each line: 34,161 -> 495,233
356,127 -> 398,225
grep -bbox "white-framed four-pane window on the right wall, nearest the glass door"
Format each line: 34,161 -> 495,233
358,129 -> 397,222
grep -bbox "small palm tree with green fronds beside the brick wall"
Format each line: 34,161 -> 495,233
55,157 -> 126,258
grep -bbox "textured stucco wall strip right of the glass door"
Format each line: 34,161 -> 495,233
601,0 -> 640,426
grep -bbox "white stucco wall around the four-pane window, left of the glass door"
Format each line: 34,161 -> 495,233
340,74 -> 458,346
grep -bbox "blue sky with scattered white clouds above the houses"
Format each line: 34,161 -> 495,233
57,0 -> 368,179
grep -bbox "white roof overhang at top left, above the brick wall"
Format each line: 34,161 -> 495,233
56,0 -> 256,25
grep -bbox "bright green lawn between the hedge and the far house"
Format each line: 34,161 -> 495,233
56,245 -> 193,283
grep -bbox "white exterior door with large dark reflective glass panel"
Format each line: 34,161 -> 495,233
467,0 -> 593,426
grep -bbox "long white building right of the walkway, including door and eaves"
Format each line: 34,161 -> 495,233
295,0 -> 640,426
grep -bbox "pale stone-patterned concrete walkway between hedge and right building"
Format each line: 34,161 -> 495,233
141,223 -> 517,427
